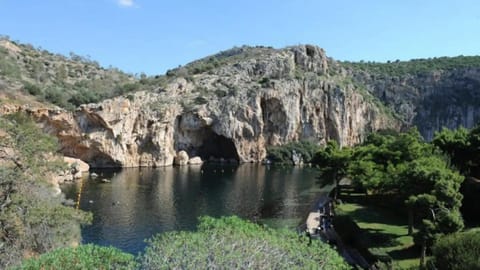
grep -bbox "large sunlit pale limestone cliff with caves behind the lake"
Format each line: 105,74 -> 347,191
0,45 -> 400,167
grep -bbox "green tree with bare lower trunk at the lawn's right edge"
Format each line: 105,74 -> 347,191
401,156 -> 463,266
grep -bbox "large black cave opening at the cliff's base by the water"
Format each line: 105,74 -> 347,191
199,129 -> 240,162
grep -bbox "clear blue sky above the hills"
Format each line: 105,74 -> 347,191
0,0 -> 480,75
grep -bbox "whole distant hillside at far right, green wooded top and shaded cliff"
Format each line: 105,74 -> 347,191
342,56 -> 480,140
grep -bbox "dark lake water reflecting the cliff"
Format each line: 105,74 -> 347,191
62,164 -> 328,254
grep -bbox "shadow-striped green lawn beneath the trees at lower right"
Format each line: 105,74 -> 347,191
337,193 -> 420,269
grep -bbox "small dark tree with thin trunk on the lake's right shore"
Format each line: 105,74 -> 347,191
312,140 -> 352,200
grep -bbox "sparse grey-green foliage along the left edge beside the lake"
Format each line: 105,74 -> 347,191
0,114 -> 90,267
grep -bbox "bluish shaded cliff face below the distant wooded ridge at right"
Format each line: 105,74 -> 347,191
348,67 -> 480,140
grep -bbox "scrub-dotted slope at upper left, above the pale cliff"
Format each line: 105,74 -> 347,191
0,36 -> 142,110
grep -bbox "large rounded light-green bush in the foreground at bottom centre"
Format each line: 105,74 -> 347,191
140,217 -> 349,269
